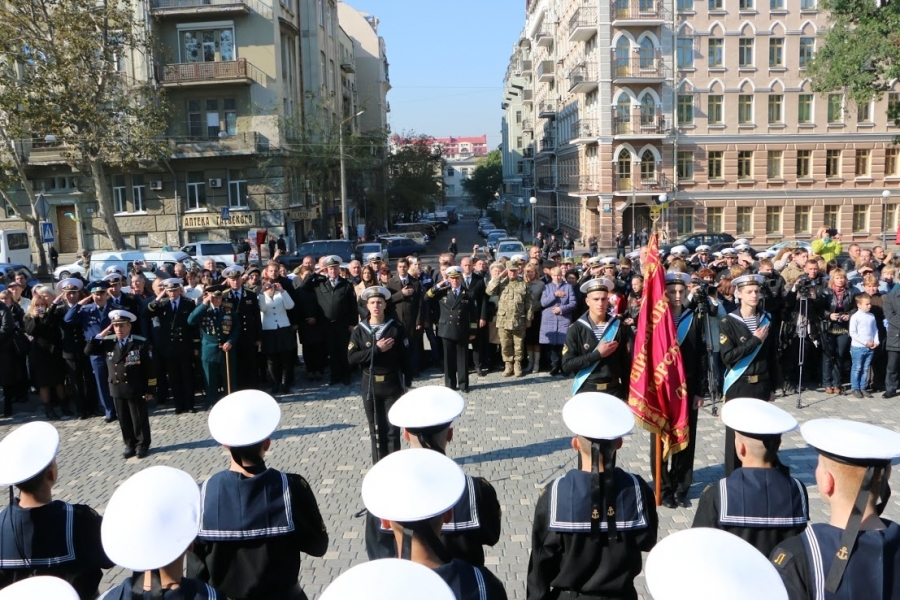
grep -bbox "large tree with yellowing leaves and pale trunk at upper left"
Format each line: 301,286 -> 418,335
0,0 -> 167,249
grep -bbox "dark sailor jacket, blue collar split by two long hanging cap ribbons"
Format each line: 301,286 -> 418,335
525,467 -> 658,600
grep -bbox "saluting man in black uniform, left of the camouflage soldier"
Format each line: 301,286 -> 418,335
428,267 -> 478,392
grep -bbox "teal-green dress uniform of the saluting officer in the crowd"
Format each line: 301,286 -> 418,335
188,302 -> 239,404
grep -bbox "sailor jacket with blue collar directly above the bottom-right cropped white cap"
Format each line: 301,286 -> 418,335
692,467 -> 809,556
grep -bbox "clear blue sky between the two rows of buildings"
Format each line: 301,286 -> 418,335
347,0 -> 525,149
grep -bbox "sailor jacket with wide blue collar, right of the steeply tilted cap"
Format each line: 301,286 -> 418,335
188,469 -> 328,600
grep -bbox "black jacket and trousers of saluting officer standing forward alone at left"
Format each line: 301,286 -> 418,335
84,335 -> 156,454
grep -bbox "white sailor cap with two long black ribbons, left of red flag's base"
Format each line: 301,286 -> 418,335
563,392 -> 634,440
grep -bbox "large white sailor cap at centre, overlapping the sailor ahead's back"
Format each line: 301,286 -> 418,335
362,448 -> 466,523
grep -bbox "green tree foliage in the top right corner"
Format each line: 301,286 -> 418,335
808,0 -> 900,127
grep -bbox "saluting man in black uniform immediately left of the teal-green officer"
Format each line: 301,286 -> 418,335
147,277 -> 200,415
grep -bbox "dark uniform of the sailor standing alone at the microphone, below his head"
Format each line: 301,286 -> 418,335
347,319 -> 412,463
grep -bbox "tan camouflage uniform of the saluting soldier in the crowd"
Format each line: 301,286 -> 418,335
485,275 -> 534,376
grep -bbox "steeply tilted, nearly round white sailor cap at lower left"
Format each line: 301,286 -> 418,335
100,466 -> 200,571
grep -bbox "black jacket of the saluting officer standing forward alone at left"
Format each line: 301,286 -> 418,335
84,335 -> 156,400
